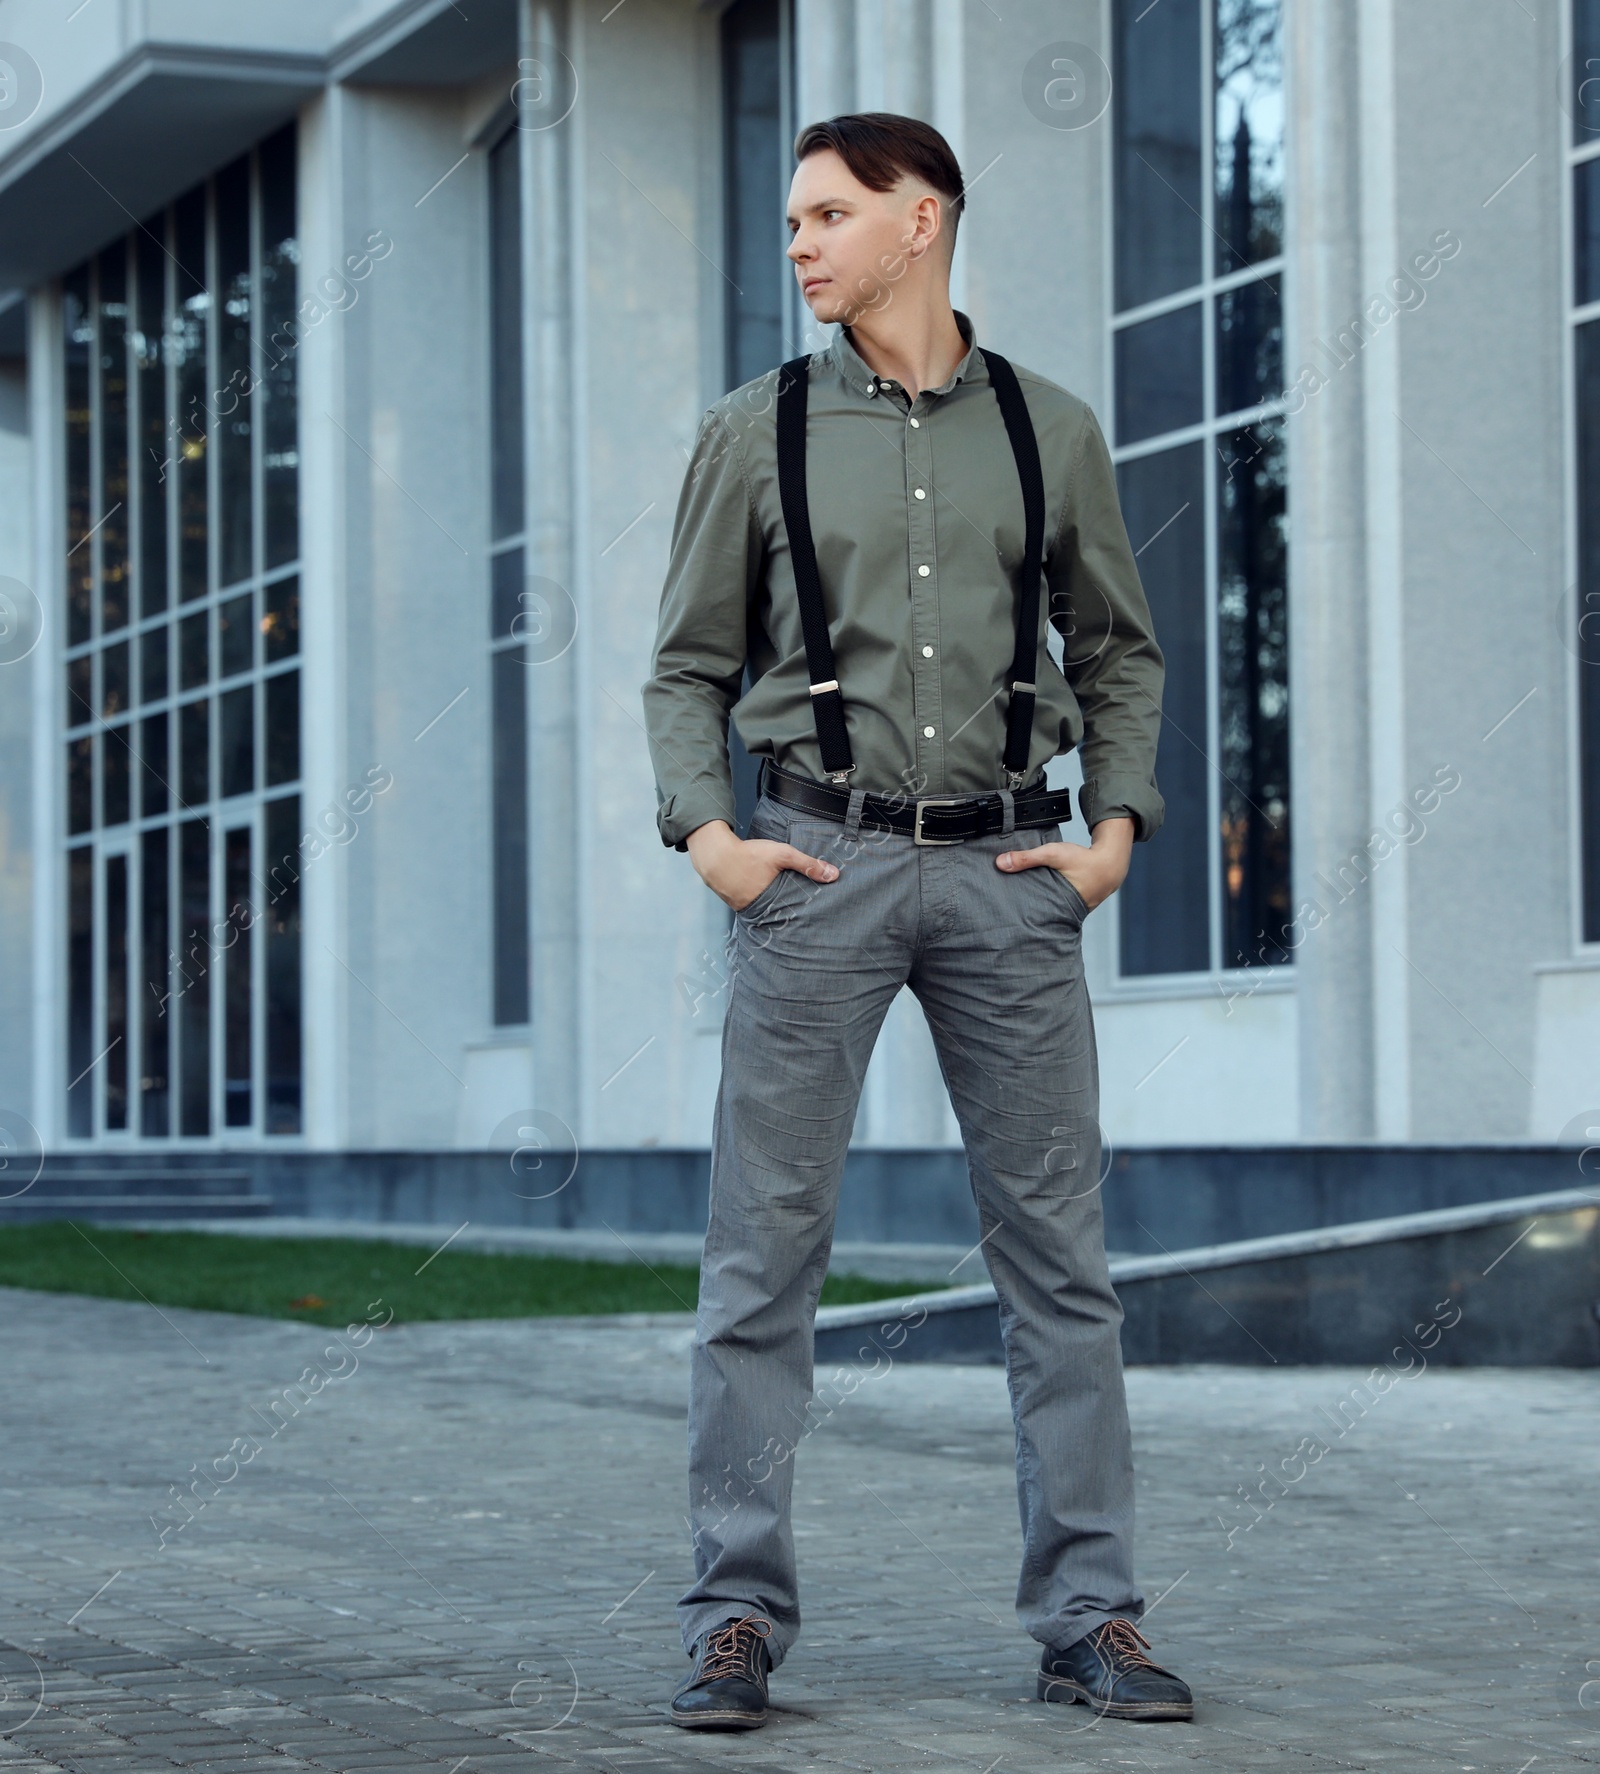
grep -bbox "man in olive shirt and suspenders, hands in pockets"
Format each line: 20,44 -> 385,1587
644,114 -> 1192,1730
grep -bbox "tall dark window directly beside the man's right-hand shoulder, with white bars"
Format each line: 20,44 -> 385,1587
1112,0 -> 1293,977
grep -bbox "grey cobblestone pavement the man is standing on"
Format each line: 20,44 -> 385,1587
0,1291 -> 1600,1774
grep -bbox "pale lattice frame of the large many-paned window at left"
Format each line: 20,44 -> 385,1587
56,134 -> 307,1155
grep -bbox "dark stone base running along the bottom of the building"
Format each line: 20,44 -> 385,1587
0,1144 -> 1582,1254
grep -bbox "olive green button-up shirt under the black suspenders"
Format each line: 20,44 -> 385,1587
644,312 -> 1164,850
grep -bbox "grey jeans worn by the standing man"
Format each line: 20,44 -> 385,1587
678,795 -> 1144,1664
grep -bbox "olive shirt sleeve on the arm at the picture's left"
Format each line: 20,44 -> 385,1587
642,406 -> 765,850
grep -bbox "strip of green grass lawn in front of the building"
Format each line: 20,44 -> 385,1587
0,1221 -> 949,1325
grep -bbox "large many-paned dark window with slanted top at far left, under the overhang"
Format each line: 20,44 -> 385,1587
62,126 -> 302,1139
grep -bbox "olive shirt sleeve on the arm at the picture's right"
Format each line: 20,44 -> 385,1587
1047,408 -> 1165,841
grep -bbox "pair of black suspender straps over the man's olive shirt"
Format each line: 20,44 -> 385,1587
777,349 -> 1045,789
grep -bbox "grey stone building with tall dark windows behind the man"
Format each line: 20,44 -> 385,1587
0,0 -> 1600,1220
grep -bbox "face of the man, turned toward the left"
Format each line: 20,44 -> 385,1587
788,147 -> 942,326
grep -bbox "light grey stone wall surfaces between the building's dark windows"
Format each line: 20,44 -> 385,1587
0,0 -> 1600,1150
